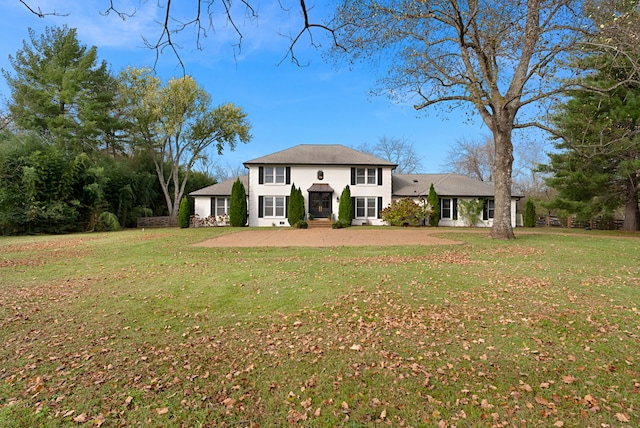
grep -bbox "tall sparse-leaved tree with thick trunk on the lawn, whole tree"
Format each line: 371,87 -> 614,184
333,0 -> 593,239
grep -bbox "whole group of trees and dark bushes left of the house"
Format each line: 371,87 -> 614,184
0,27 -> 251,234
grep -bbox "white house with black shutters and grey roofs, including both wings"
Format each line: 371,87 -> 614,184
189,144 -> 518,227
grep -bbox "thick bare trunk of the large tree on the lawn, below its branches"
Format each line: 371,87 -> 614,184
489,125 -> 515,239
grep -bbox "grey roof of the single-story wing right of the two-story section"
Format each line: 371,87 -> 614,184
393,174 -> 498,197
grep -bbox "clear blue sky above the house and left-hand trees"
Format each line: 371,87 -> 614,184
0,0 -> 496,173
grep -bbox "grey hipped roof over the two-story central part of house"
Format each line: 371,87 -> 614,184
244,144 -> 398,168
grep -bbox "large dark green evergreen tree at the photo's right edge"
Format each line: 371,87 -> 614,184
541,54 -> 640,230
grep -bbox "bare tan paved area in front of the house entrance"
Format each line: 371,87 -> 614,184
196,227 -> 460,247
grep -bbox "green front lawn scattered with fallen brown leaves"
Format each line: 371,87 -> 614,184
0,228 -> 640,427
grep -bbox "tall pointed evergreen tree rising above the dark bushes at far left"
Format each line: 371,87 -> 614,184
3,26 -> 121,154
